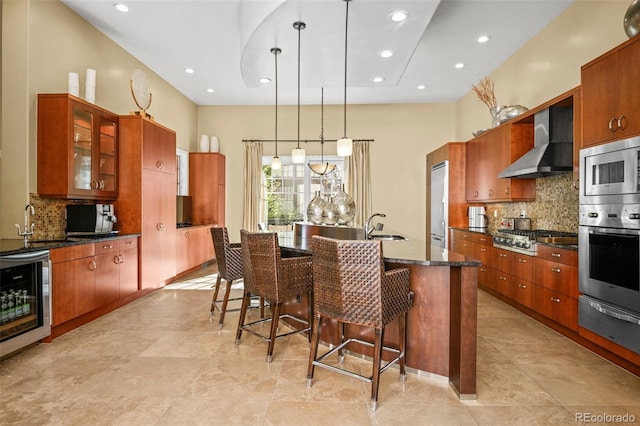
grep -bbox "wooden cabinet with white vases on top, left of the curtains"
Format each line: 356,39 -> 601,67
189,152 -> 225,226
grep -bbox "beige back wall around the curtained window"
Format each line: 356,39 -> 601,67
198,104 -> 455,240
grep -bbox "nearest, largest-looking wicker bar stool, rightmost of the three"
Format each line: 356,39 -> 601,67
307,235 -> 413,411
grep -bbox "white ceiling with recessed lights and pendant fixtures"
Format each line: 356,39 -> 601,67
62,0 -> 574,105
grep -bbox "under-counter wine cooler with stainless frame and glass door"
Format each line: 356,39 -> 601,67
0,250 -> 51,357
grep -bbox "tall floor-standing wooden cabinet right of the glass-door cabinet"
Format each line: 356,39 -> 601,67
115,115 -> 177,289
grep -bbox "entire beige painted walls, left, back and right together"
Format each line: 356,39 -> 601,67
0,0 -> 630,243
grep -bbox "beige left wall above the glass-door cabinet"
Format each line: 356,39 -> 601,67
0,0 -> 197,238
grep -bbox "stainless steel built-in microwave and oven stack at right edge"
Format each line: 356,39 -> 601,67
578,137 -> 640,353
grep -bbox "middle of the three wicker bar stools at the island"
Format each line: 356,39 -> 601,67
236,229 -> 313,362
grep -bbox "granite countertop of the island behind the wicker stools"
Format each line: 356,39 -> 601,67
281,239 -> 482,267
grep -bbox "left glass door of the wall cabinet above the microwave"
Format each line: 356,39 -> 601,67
73,108 -> 95,190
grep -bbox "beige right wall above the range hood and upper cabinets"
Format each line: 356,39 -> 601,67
456,0 -> 631,141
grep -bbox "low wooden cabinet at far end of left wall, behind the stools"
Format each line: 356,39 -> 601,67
176,225 -> 215,274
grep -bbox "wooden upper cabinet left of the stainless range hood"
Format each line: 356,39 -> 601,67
465,123 -> 536,203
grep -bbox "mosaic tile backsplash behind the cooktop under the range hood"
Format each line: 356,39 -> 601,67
485,174 -> 579,232
